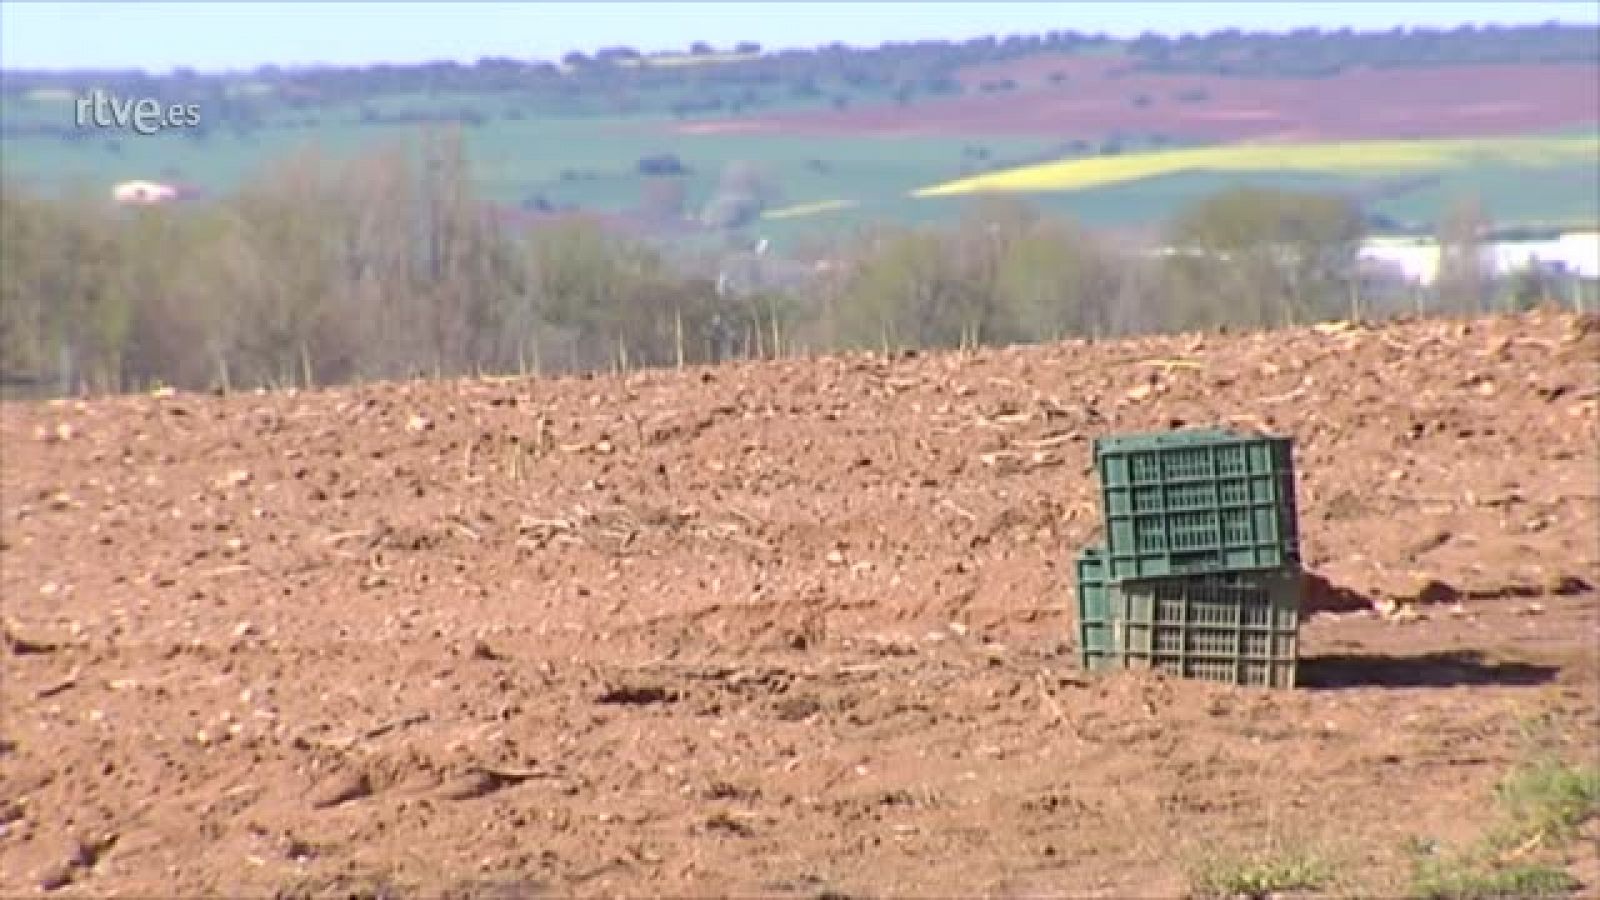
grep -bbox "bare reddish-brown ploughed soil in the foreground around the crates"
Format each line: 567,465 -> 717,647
0,314 -> 1600,897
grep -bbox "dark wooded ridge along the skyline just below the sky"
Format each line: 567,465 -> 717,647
0,21 -> 1600,135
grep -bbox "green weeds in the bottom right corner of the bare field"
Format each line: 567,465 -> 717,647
1411,757 -> 1600,900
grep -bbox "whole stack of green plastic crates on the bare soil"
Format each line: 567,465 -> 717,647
1077,429 -> 1304,687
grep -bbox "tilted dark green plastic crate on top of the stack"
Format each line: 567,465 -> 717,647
1094,429 -> 1301,583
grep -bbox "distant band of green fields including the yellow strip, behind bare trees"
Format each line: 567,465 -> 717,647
0,85 -> 1600,247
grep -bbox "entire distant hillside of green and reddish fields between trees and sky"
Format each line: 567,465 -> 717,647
0,21 -> 1600,243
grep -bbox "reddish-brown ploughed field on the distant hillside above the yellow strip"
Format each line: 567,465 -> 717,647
685,56 -> 1600,141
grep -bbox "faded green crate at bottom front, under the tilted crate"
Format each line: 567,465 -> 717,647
1107,567 -> 1304,687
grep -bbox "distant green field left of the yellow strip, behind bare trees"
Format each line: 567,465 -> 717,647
3,98 -> 1050,220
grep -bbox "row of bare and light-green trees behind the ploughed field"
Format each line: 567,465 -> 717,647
0,131 -> 1548,392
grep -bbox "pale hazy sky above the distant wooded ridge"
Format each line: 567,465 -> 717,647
0,0 -> 1600,70
